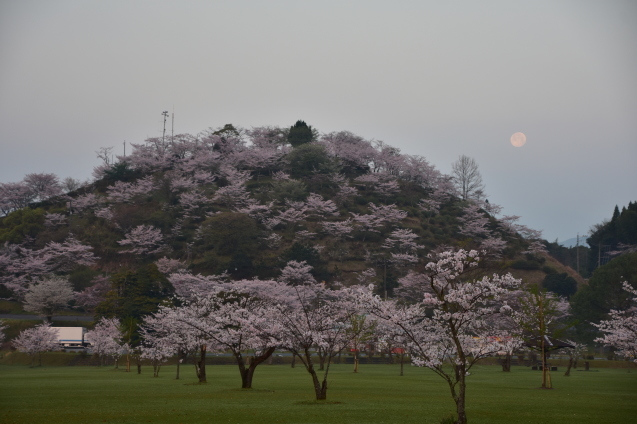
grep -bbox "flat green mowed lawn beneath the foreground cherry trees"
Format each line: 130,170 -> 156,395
0,365 -> 637,424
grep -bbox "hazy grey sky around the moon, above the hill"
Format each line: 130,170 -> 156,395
0,0 -> 637,241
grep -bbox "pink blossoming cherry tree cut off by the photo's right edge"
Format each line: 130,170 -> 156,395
593,281 -> 637,363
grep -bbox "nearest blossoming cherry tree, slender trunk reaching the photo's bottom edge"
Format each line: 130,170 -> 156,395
359,250 -> 520,424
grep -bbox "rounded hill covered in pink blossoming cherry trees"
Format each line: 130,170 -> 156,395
0,123 -> 545,316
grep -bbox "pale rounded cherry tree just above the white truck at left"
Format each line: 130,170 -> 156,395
24,275 -> 75,323
